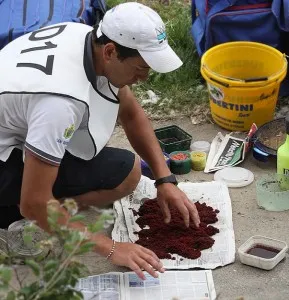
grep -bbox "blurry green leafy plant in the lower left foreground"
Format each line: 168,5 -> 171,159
0,199 -> 112,300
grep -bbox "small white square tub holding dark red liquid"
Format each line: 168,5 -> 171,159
238,235 -> 288,270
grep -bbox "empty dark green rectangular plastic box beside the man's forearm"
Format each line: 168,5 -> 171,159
155,125 -> 192,153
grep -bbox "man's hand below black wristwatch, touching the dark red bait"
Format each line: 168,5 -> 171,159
157,183 -> 200,227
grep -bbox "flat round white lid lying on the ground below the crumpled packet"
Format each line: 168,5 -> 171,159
214,167 -> 254,187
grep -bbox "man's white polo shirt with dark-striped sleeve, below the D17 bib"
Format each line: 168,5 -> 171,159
0,94 -> 87,165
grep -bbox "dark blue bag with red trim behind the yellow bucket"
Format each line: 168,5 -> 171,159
191,0 -> 280,55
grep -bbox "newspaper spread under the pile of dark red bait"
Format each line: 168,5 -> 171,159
112,176 -> 235,269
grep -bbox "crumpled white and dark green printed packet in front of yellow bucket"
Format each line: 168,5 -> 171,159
204,123 -> 257,173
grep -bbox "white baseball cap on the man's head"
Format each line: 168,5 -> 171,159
97,2 -> 183,73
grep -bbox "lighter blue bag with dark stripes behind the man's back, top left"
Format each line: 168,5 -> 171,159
0,0 -> 106,49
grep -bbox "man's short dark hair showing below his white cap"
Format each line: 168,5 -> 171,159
92,26 -> 140,61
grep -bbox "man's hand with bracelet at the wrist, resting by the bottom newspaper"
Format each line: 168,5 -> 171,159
110,243 -> 165,280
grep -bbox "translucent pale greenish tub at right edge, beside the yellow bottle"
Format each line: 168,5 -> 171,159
256,174 -> 289,211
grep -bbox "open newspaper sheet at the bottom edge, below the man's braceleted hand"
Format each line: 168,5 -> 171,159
76,270 -> 216,300
